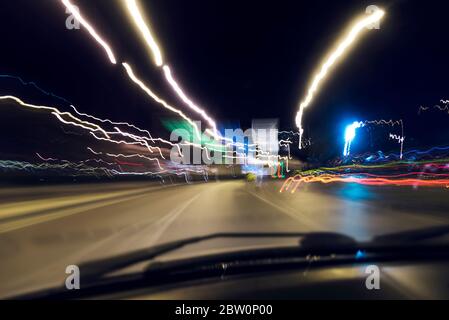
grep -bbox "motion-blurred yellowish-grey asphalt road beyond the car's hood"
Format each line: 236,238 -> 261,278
0,180 -> 449,297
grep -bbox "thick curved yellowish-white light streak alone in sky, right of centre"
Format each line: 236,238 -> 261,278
296,9 -> 385,149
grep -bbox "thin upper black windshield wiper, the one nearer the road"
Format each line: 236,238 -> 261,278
80,232 -> 356,281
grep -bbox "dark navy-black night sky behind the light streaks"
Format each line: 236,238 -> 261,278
0,0 -> 449,160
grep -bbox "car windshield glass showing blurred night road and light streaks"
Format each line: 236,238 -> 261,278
0,0 -> 449,297
